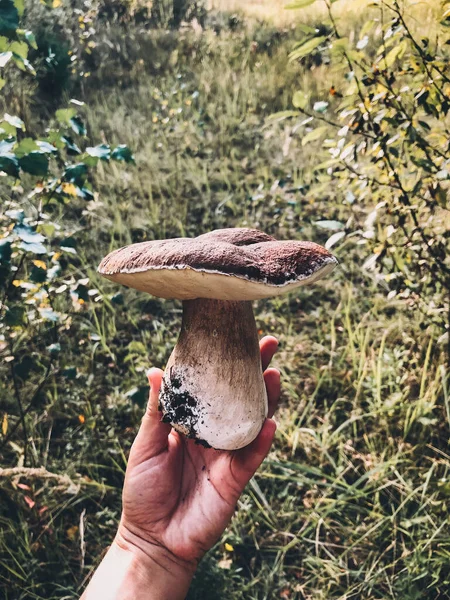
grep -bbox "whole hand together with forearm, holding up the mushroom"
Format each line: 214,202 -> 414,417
80,336 -> 280,600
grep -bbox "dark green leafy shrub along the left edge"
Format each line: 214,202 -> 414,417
0,0 -> 133,464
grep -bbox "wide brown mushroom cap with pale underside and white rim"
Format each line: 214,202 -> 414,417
98,228 -> 337,300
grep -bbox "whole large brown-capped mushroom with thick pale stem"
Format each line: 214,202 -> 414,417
98,228 -> 337,450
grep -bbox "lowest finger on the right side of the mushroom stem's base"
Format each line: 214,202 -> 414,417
233,419 -> 277,488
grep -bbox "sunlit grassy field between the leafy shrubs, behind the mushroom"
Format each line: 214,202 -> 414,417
0,0 -> 450,600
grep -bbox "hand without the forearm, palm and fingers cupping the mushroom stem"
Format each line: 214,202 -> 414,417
123,338 -> 279,561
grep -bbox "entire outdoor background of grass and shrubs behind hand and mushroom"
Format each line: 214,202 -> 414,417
0,0 -> 450,600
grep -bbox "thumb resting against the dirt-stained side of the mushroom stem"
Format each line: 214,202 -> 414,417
130,369 -> 172,462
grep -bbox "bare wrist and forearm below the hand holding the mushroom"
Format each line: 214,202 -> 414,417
81,534 -> 192,600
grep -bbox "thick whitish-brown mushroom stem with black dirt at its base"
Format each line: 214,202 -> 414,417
159,299 -> 267,450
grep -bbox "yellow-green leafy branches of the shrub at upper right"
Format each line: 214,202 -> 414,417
284,0 -> 450,359
